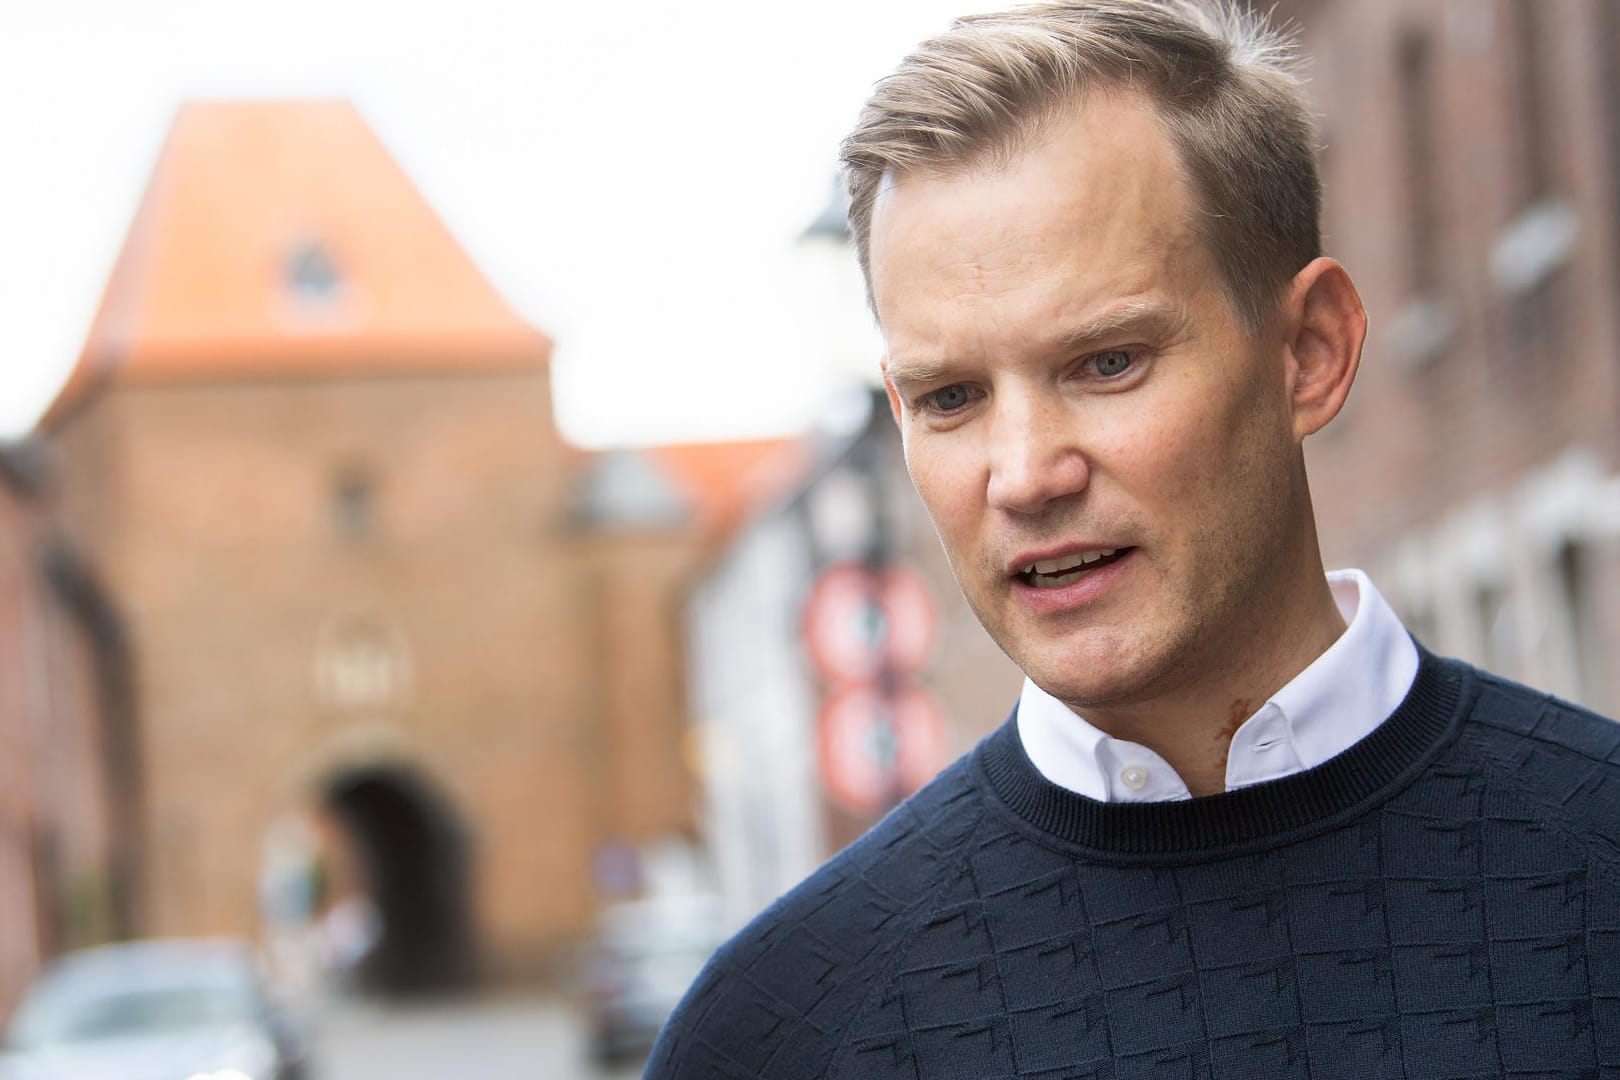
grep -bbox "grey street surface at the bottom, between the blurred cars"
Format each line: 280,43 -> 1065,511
311,997 -> 642,1080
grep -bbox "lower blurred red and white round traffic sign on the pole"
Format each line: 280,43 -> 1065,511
816,685 -> 948,814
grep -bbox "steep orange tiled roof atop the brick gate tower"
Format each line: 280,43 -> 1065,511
42,100 -> 551,426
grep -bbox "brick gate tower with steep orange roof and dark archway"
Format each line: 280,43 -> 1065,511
42,102 -> 729,986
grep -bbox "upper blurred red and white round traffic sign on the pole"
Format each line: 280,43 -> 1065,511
804,562 -> 935,683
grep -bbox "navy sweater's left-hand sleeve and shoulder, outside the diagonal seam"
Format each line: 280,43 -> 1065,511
646,755 -> 982,1080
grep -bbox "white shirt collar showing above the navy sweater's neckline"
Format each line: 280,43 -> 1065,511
1017,570 -> 1418,803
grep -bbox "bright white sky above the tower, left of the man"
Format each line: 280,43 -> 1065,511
0,0 -> 965,445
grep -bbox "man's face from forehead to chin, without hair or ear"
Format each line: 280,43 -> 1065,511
872,96 -> 1309,708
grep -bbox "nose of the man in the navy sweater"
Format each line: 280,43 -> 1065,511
988,400 -> 1090,513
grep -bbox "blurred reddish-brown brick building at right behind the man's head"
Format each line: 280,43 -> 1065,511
1281,0 -> 1620,712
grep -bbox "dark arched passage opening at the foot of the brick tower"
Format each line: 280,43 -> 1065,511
326,766 -> 475,994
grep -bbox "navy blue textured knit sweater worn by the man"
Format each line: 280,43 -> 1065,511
646,653 -> 1620,1080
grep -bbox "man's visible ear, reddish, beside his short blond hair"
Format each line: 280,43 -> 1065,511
1283,257 -> 1367,442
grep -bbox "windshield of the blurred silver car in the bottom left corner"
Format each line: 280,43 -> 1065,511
11,986 -> 253,1048
